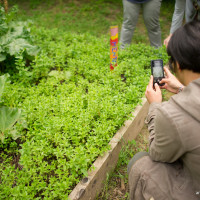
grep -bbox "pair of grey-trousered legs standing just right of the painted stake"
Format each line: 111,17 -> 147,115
120,0 -> 162,49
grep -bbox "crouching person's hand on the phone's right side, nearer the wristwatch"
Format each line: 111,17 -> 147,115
160,67 -> 184,94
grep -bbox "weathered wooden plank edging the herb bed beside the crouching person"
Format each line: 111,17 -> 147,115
69,98 -> 149,200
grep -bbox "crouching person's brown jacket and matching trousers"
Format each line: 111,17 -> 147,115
129,79 -> 200,200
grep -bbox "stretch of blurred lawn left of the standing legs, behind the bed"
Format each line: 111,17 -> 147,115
10,0 -> 122,36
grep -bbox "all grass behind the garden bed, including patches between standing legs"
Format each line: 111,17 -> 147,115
10,0 -> 174,44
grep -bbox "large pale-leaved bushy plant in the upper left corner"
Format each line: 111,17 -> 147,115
0,6 -> 38,69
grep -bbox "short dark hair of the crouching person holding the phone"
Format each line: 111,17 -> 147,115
167,21 -> 200,73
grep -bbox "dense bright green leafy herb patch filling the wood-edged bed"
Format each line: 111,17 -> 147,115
0,1 -> 173,199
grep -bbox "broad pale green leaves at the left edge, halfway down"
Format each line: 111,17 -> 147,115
0,75 -> 21,142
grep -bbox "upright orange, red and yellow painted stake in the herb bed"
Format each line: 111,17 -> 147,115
110,26 -> 118,70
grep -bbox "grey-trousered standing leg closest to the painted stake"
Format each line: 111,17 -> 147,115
120,0 -> 141,49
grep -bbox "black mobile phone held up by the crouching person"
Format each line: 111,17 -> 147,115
151,59 -> 165,86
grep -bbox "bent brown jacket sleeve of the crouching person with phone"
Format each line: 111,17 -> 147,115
146,103 -> 184,163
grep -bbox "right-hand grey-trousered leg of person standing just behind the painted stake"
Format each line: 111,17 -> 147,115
143,0 -> 162,48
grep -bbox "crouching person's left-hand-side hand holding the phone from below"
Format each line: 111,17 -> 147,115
145,76 -> 162,104
